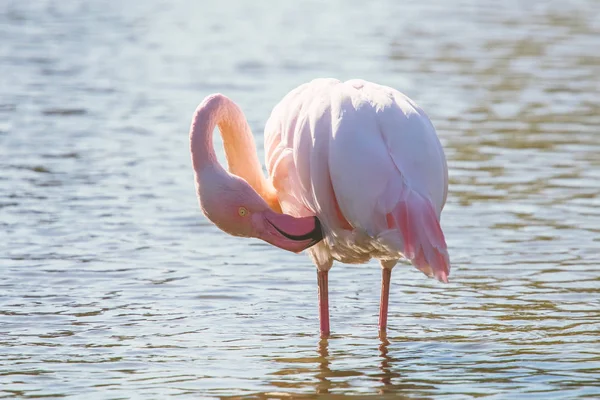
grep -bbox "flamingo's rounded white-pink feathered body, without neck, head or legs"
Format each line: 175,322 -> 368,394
265,79 -> 450,281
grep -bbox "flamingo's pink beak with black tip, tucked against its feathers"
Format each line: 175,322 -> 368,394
261,212 -> 323,253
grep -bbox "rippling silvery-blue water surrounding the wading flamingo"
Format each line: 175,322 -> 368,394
0,0 -> 600,399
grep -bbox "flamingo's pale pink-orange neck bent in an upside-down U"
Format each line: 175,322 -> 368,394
190,94 -> 281,212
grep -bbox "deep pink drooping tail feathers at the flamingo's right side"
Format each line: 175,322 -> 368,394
387,189 -> 450,282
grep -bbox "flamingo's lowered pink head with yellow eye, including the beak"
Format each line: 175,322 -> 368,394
197,171 -> 323,253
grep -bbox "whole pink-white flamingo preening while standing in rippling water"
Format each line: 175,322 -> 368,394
190,79 -> 450,337
